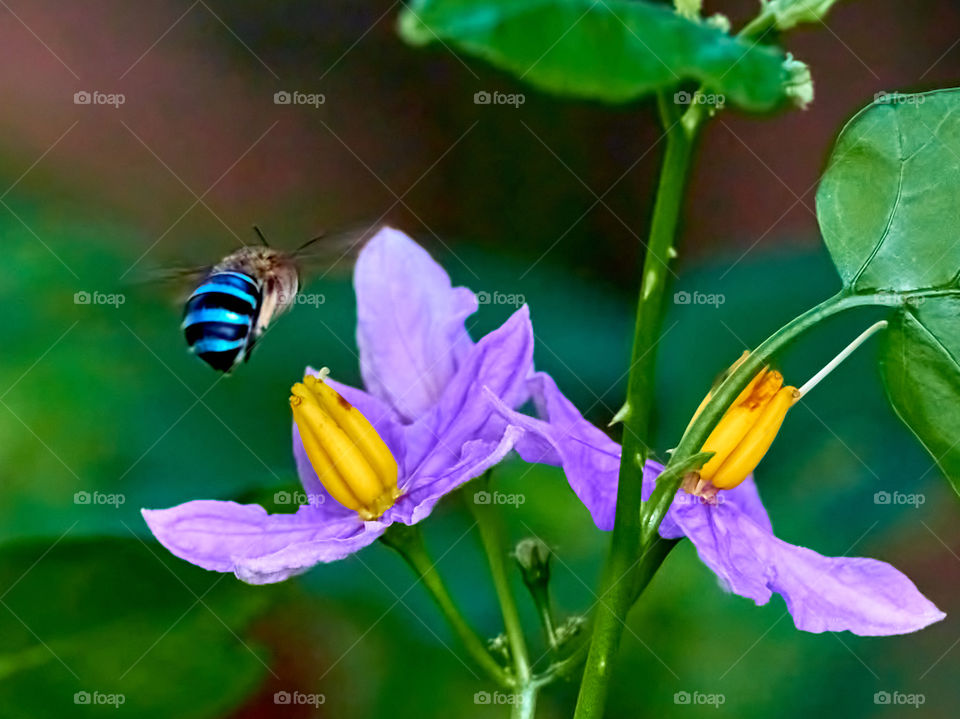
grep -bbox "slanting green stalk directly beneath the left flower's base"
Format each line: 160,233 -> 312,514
380,523 -> 513,688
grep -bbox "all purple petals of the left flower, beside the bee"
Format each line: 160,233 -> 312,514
143,228 -> 533,584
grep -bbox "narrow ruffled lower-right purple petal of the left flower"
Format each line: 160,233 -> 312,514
387,427 -> 523,524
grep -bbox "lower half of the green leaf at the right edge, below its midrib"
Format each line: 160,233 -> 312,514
880,297 -> 960,494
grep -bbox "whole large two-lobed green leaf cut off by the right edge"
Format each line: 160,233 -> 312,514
817,90 -> 960,491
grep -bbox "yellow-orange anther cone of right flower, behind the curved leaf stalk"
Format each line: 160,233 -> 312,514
700,358 -> 800,489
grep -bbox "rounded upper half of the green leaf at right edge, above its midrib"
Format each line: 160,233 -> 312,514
817,89 -> 960,292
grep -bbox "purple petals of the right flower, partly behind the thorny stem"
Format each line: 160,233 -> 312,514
491,373 -> 946,636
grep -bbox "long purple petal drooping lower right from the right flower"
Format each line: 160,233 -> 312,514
674,501 -> 945,636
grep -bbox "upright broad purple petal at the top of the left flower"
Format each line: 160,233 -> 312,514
354,228 -> 477,420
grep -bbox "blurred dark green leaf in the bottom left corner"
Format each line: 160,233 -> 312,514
0,538 -> 276,719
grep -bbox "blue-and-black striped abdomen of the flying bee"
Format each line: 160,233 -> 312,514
182,272 -> 263,372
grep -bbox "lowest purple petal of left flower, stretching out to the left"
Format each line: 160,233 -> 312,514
141,500 -> 387,584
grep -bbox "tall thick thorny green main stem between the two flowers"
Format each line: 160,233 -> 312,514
574,95 -> 703,719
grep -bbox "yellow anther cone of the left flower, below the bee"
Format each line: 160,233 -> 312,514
290,369 -> 400,521
